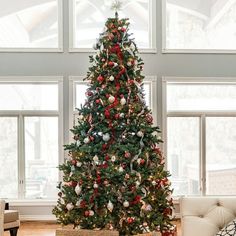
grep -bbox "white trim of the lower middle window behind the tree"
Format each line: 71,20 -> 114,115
67,76 -> 157,142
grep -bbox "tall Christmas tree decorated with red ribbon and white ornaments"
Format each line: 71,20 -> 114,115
53,4 -> 173,235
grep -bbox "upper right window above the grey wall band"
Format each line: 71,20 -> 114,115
163,0 -> 236,52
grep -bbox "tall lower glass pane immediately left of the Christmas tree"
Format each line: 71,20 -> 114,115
25,117 -> 59,198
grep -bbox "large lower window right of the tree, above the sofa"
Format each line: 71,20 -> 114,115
163,78 -> 236,196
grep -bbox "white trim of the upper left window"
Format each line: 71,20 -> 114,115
0,0 -> 63,52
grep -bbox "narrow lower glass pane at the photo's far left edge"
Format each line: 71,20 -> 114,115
0,117 -> 18,198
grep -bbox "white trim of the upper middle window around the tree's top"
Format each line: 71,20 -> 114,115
69,0 -> 157,54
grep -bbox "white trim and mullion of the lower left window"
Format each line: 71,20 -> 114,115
0,76 -> 64,199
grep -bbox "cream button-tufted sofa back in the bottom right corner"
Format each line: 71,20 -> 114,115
180,196 -> 236,236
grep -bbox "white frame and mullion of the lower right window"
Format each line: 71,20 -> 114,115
162,76 -> 236,199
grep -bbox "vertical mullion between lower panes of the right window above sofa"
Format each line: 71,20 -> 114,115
200,115 -> 206,196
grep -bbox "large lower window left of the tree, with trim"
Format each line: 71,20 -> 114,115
0,77 -> 62,199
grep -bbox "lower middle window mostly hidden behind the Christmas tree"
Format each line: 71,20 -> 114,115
69,76 -> 156,130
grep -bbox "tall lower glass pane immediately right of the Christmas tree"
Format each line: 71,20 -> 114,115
167,117 -> 200,195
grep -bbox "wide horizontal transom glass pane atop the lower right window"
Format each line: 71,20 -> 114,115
167,84 -> 236,111
